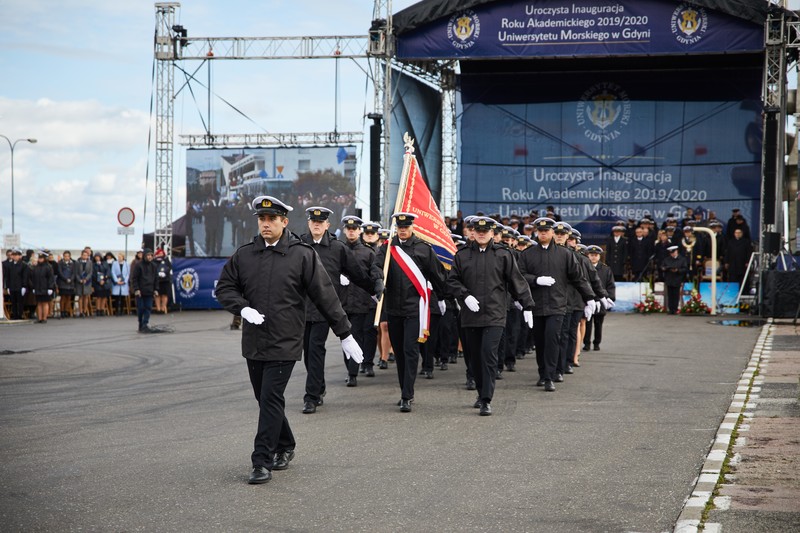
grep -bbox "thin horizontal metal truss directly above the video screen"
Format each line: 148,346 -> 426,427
179,131 -> 364,148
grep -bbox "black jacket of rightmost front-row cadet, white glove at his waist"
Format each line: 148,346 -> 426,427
519,241 -> 594,316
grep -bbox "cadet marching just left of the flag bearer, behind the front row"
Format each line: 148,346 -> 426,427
341,215 -> 383,378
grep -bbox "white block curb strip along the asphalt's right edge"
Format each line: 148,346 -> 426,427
673,319 -> 772,533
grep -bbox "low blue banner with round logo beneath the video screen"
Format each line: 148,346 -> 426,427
172,257 -> 228,309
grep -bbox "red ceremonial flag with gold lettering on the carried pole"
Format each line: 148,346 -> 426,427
397,152 -> 457,270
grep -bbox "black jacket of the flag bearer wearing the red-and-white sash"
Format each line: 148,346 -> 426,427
375,235 -> 450,317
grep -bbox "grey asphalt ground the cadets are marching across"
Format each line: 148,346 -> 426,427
0,311 -> 760,532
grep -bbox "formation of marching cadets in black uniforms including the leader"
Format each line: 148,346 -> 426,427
211,196 -> 615,484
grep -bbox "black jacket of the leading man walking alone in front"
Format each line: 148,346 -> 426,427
216,229 -> 350,361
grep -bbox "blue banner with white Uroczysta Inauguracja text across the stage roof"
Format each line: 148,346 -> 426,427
397,0 -> 764,59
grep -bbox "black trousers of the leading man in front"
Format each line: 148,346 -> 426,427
247,359 -> 295,470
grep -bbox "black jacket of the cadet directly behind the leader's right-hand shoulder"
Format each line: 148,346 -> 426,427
300,231 -> 374,322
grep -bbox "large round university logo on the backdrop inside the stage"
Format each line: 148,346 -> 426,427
576,82 -> 631,142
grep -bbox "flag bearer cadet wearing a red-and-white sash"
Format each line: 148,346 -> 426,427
376,213 -> 447,413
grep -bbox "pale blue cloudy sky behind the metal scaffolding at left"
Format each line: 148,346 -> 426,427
0,0 -> 414,251
